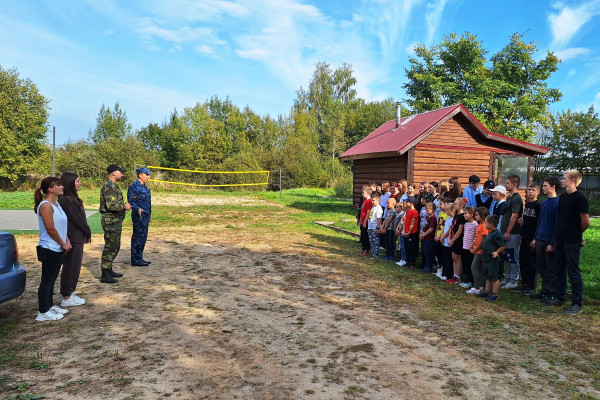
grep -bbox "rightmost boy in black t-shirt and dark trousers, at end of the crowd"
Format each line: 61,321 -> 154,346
554,170 -> 590,315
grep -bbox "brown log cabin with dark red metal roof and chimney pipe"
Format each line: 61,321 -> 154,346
340,104 -> 548,205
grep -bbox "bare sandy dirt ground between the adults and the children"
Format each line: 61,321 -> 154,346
0,199 -> 596,400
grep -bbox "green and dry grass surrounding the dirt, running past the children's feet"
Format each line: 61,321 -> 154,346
0,189 -> 600,399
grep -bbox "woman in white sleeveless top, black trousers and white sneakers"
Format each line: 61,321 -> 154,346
33,176 -> 71,321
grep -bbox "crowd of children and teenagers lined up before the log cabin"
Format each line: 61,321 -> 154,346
357,171 -> 589,314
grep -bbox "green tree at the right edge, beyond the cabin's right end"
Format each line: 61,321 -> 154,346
544,106 -> 600,174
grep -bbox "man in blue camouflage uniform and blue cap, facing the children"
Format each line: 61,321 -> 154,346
127,167 -> 152,267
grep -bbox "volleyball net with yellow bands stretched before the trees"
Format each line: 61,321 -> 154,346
147,165 -> 271,187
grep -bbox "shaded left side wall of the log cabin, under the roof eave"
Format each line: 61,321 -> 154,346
353,154 -> 407,206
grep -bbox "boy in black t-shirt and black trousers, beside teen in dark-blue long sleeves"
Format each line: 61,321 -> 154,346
513,182 -> 542,296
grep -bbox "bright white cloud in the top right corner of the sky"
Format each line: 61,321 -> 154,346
548,0 -> 600,47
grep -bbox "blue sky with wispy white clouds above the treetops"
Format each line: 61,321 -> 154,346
0,0 -> 600,144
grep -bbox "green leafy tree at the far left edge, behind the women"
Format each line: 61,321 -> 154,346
0,66 -> 49,182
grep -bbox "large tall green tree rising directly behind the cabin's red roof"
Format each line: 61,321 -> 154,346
403,32 -> 561,140
